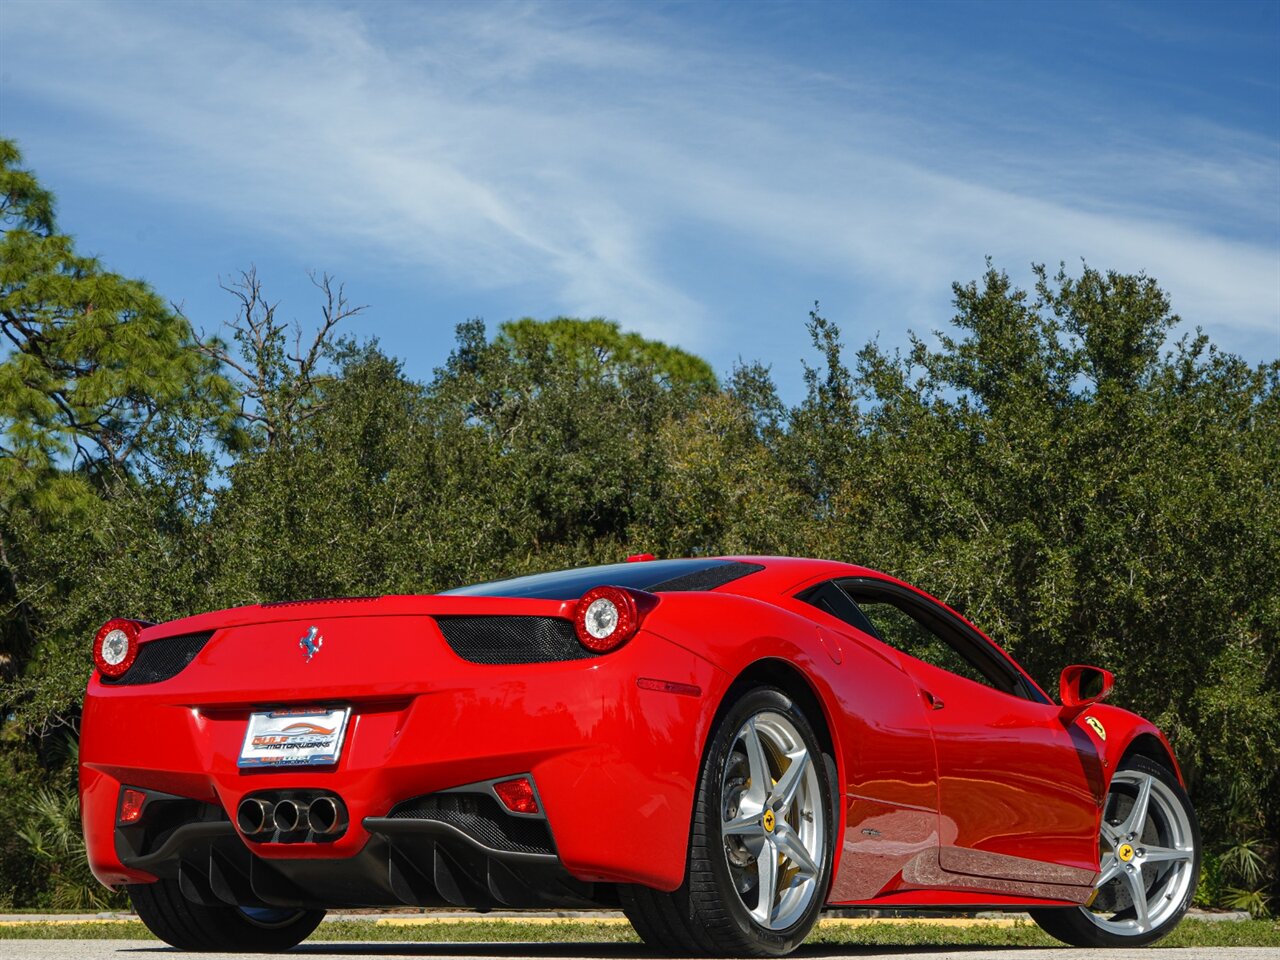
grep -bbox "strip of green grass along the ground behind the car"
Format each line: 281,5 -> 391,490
0,920 -> 1280,950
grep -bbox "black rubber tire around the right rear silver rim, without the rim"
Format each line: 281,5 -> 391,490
620,687 -> 840,956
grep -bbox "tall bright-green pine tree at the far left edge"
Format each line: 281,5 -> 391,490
0,141 -> 225,677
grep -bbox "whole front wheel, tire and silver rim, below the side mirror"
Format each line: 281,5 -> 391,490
1030,756 -> 1201,947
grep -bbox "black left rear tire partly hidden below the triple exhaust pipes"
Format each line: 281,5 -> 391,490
128,881 -> 325,954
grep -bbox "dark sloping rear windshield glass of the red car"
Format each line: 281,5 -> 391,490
442,559 -> 764,600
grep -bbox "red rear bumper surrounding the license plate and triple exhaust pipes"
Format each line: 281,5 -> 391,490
81,621 -> 728,905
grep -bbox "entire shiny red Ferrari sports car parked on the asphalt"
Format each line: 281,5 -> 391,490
81,557 -> 1201,956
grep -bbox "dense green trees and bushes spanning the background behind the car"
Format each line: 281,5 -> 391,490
0,138 -> 1280,913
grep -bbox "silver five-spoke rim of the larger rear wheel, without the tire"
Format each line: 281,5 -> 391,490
721,710 -> 827,929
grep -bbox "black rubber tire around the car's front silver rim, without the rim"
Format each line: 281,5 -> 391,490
1030,756 -> 1201,947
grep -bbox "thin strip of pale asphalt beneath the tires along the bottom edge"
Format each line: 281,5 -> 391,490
0,940 -> 1280,960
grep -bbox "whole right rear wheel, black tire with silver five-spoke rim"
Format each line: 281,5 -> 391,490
622,689 -> 836,956
